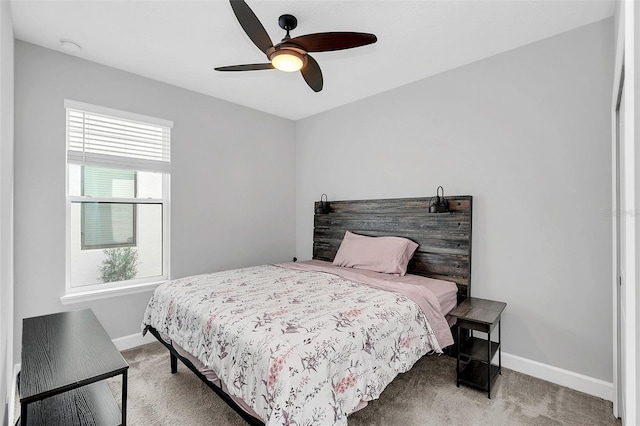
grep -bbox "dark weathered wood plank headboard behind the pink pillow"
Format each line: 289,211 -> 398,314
313,195 -> 473,303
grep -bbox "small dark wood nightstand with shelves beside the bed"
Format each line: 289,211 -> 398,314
449,297 -> 507,399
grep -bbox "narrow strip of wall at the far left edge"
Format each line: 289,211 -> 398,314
0,2 -> 13,425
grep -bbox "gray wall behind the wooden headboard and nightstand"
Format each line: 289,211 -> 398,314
296,19 -> 614,382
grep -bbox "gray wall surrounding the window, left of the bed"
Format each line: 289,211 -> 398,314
14,41 -> 295,356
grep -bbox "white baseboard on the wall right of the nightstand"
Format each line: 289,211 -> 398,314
502,352 -> 613,401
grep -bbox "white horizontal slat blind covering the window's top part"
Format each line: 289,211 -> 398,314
65,100 -> 173,172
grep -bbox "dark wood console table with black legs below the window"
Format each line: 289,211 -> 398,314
20,309 -> 129,426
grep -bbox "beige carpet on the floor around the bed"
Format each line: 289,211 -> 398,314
109,343 -> 620,426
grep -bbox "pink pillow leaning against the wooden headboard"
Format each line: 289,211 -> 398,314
332,231 -> 418,276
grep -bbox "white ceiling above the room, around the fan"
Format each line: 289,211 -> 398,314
7,0 -> 615,120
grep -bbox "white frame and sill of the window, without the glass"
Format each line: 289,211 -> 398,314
60,99 -> 173,298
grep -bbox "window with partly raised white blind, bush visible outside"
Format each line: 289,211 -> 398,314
65,100 -> 173,293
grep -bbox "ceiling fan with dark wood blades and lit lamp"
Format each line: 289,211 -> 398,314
215,0 -> 378,92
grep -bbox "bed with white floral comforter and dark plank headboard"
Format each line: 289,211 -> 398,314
142,196 -> 472,425
